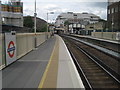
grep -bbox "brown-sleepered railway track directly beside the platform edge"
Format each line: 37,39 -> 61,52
63,36 -> 120,90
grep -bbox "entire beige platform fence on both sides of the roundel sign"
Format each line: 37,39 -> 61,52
0,33 -> 50,69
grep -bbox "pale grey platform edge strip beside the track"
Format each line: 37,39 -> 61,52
57,37 -> 84,88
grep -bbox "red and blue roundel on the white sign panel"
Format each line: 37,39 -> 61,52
7,41 -> 15,58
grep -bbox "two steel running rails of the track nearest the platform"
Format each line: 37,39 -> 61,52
62,37 -> 120,89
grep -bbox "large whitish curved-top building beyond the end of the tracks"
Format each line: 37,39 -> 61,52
55,12 -> 100,33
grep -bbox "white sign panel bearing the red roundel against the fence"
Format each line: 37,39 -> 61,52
5,33 -> 16,65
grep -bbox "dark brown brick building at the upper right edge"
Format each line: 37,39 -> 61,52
107,0 -> 120,32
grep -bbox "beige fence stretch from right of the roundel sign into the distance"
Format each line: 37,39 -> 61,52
16,33 -> 49,59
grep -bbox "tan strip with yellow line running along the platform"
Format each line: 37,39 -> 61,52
38,37 -> 59,88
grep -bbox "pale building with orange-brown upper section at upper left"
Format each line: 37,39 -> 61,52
1,0 -> 23,27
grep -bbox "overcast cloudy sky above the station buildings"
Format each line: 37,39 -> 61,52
2,0 -> 107,21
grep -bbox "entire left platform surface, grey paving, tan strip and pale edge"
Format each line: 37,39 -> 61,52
2,35 -> 84,89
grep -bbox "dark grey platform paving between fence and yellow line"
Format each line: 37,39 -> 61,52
2,37 -> 56,88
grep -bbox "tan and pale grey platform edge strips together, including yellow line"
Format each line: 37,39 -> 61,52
39,36 -> 84,89
